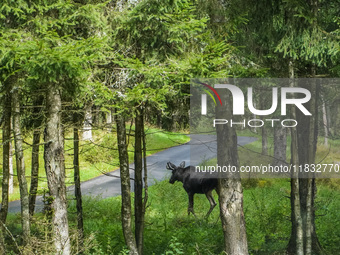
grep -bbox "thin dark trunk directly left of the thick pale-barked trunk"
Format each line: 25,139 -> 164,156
29,129 -> 40,216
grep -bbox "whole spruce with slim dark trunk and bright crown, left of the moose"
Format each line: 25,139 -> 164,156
113,0 -> 207,254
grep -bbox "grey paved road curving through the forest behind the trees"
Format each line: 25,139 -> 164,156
9,135 -> 257,213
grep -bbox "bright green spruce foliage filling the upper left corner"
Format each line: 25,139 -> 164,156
0,0 -> 109,110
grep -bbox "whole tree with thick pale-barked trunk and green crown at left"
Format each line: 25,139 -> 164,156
18,2 -> 105,254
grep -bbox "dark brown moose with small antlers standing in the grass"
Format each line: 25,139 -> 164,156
166,161 -> 217,218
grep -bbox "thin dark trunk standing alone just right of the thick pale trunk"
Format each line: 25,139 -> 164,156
73,113 -> 84,253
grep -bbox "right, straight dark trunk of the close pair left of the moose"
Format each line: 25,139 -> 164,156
135,106 -> 144,254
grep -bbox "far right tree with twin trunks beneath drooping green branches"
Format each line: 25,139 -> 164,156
277,0 -> 337,254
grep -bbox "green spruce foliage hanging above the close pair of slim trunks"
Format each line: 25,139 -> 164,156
106,0 -> 207,125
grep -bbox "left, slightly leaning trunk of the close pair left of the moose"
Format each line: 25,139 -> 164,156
116,112 -> 138,255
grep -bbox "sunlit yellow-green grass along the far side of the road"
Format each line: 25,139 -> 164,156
0,126 -> 189,201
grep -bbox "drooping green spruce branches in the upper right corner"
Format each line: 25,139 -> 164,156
276,1 -> 340,67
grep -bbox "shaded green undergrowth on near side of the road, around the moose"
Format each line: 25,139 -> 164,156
8,179 -> 340,255
